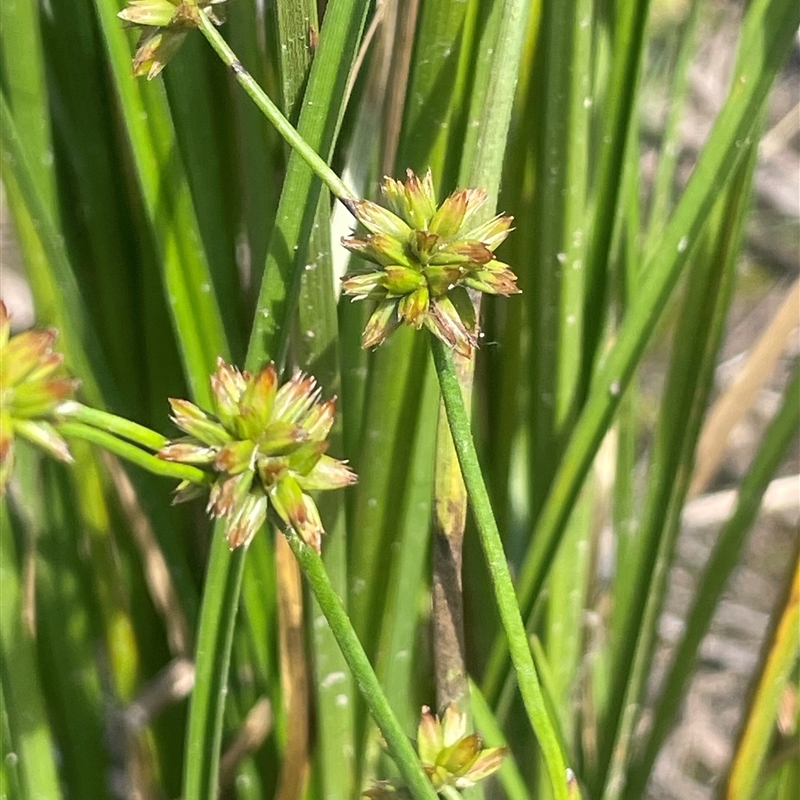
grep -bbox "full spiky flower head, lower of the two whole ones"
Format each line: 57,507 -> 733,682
158,358 -> 356,551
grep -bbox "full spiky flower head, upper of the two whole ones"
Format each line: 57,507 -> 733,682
342,170 -> 519,355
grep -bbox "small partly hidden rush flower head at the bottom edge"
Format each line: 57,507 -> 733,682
364,705 -> 507,800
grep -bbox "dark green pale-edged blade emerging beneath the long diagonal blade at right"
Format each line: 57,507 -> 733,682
600,139 -> 755,800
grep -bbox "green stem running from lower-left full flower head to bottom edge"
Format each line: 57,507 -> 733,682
285,529 -> 436,800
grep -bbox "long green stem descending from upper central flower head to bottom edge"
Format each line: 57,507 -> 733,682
431,335 -> 569,800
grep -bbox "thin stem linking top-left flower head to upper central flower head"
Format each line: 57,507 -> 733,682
199,10 -> 357,206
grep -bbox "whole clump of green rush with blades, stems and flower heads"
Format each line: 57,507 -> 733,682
0,0 -> 800,800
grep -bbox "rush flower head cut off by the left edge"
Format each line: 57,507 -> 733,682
0,300 -> 78,494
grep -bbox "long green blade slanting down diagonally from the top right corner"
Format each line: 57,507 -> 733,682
484,0 -> 800,698
